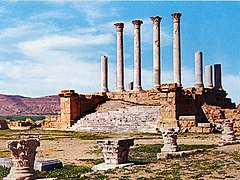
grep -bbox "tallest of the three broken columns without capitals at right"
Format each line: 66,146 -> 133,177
194,51 -> 203,88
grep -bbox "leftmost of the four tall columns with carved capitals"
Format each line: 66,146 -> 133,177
114,22 -> 124,92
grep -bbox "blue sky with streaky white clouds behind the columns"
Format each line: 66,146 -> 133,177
0,1 -> 240,103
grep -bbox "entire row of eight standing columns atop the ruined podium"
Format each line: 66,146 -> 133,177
101,12 -> 221,92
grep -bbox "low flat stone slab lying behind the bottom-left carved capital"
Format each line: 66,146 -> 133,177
0,157 -> 63,172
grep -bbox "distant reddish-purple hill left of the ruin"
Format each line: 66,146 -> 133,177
0,94 -> 60,116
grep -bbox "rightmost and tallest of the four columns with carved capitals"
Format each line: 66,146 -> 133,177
171,13 -> 182,87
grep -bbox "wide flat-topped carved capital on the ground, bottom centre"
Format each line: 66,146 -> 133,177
97,139 -> 134,164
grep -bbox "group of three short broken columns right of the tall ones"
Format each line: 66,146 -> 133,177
194,51 -> 222,90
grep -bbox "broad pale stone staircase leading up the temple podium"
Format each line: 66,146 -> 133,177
67,106 -> 161,132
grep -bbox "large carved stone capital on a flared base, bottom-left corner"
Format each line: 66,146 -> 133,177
4,139 -> 40,180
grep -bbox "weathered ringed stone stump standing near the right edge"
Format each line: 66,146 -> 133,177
221,119 -> 236,144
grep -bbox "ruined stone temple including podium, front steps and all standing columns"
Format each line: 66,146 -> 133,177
43,13 -> 240,133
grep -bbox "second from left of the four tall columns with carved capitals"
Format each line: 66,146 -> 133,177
132,20 -> 143,91
